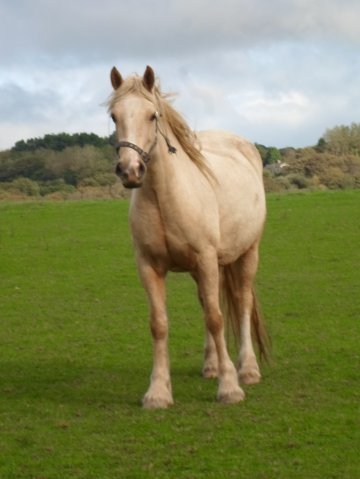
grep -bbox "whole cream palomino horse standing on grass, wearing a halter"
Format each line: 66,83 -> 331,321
108,66 -> 267,408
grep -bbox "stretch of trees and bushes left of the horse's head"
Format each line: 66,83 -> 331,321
0,133 -> 117,198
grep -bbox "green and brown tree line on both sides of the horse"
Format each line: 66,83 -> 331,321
0,123 -> 360,199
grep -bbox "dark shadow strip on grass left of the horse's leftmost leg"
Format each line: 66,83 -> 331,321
0,359 -> 148,406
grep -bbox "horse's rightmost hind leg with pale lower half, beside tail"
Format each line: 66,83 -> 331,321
232,244 -> 261,384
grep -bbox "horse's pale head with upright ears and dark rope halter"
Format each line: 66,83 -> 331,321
109,66 -> 159,188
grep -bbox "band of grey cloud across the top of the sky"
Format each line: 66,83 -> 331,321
1,0 -> 360,66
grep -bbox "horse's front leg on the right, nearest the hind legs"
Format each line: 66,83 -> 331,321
197,251 -> 245,403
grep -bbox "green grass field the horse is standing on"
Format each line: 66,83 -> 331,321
0,191 -> 360,479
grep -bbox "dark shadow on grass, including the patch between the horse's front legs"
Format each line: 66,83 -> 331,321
0,358 -> 229,407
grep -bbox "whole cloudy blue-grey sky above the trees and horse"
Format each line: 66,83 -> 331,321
0,0 -> 360,149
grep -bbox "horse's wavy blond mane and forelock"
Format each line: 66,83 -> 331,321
108,75 -> 212,176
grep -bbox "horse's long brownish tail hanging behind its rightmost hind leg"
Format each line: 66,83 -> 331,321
220,265 -> 270,361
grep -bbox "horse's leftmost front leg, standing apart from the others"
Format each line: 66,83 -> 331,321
138,261 -> 173,409
